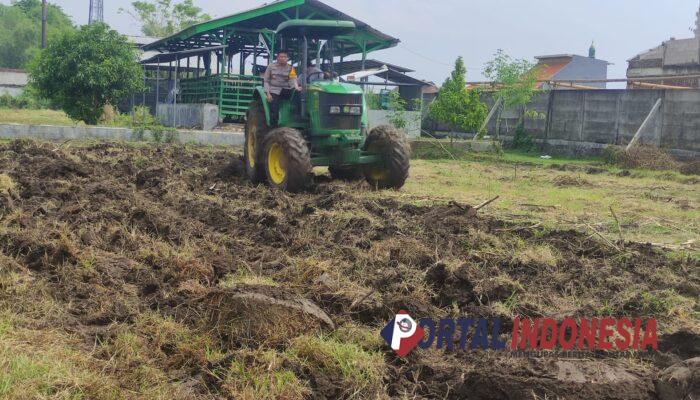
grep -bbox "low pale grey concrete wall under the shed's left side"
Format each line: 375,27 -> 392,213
156,103 -> 219,130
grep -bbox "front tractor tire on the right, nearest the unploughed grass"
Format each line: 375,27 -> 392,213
363,125 -> 411,189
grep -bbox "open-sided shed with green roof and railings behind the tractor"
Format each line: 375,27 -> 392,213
142,0 -> 399,119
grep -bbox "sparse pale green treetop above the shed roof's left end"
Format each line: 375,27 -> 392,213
119,0 -> 211,37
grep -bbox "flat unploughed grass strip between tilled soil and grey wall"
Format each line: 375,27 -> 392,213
400,152 -> 700,250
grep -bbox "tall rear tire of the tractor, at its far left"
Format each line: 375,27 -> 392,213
243,100 -> 269,183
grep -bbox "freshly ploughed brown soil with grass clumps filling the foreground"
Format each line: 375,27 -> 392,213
0,141 -> 700,400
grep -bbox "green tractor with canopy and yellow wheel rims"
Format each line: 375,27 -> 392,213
244,20 -> 409,192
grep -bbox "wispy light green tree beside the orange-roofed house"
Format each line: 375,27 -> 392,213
484,49 -> 537,108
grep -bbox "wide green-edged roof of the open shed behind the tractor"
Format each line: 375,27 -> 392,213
143,0 -> 399,56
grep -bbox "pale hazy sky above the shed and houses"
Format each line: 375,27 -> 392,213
5,0 -> 700,83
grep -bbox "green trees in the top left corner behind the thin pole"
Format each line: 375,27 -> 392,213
0,0 -> 75,69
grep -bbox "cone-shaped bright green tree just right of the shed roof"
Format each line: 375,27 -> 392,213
428,57 -> 487,132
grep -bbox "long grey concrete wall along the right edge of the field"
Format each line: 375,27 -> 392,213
484,89 -> 700,158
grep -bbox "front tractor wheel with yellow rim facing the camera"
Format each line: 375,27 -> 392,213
263,128 -> 313,192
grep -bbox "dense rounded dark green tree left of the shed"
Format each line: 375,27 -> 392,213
30,24 -> 144,124
